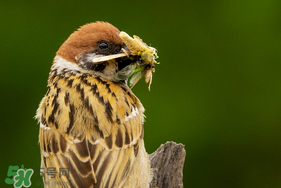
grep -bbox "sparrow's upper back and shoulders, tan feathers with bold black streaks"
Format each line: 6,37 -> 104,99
37,71 -> 144,149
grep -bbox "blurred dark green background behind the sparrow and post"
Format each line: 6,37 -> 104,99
0,0 -> 281,188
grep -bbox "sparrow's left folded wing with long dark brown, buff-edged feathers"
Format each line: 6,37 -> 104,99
40,129 -> 96,187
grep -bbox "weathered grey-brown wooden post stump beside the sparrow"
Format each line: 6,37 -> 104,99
149,142 -> 186,188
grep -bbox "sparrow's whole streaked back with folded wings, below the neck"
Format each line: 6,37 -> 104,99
37,75 -> 143,187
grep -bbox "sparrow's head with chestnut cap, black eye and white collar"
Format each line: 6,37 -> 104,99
53,22 -> 132,81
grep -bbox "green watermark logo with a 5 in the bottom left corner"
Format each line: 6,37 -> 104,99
5,165 -> 34,188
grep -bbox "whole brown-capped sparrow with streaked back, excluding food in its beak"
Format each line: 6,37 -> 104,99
36,22 -> 151,188
